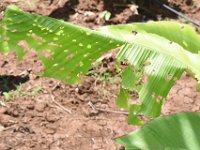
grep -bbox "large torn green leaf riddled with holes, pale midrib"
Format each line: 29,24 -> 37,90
0,7 -> 200,117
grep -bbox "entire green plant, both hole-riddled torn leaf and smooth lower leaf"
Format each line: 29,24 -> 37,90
0,6 -> 200,150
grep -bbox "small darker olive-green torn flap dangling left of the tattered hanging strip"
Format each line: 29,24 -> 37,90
116,88 -> 129,108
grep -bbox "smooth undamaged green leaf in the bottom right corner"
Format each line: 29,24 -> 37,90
116,113 -> 200,150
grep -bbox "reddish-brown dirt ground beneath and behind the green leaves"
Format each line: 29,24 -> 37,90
0,0 -> 200,150
